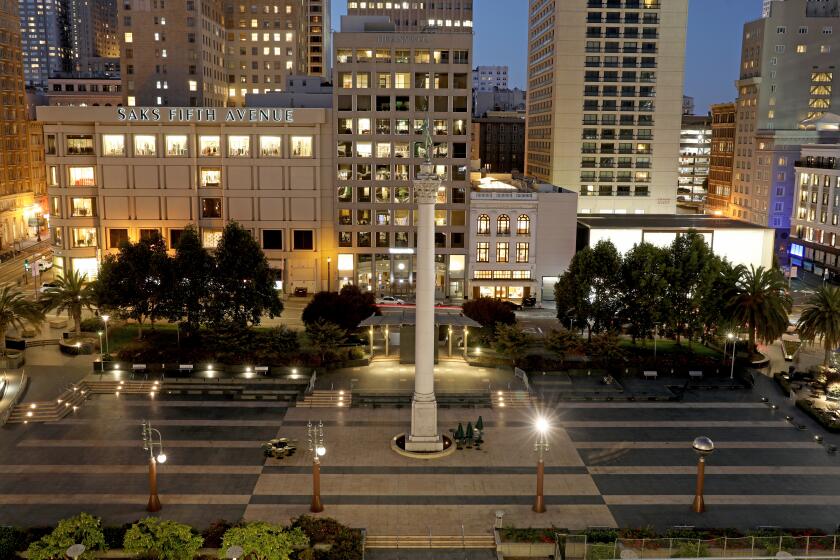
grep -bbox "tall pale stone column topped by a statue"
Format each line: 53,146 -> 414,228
405,117 -> 443,453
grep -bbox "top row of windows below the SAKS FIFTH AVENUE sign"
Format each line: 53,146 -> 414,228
53,134 -> 313,158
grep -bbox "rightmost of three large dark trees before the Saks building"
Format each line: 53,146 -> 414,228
205,222 -> 283,326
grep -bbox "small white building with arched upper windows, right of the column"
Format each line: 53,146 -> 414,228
469,174 -> 577,302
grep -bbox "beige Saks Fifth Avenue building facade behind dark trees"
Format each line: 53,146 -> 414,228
38,107 -> 335,292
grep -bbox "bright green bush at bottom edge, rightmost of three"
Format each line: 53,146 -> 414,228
221,521 -> 309,560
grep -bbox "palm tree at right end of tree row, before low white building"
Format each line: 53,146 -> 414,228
727,265 -> 792,352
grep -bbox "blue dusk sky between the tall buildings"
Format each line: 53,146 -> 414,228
332,0 -> 761,114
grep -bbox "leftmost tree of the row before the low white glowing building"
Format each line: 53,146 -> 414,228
554,241 -> 622,337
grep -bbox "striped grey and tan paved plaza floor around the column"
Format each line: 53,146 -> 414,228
0,370 -> 840,535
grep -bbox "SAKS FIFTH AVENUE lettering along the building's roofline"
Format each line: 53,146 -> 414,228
117,107 -> 295,123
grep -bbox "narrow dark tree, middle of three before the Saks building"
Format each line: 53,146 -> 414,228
167,225 -> 215,335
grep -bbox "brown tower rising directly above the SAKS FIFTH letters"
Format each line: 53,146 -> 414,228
118,0 -> 228,107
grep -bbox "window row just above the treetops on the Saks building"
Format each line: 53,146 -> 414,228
52,226 -> 315,251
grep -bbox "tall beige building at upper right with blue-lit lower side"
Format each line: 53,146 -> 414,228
731,0 -> 840,264
